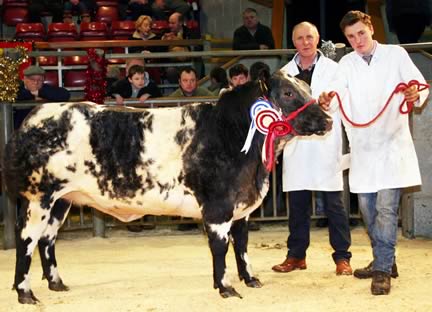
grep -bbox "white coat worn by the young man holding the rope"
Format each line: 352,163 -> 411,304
328,44 -> 429,193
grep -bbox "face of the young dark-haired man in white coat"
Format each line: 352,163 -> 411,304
344,21 -> 374,55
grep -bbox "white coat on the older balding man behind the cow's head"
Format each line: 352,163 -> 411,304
281,55 -> 343,192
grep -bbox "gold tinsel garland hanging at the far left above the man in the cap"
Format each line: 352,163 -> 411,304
0,47 -> 28,103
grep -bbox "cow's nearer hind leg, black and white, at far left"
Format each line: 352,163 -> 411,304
14,199 -> 48,304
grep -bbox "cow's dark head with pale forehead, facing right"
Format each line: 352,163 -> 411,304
268,71 -> 332,135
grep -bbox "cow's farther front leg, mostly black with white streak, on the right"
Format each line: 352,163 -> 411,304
231,219 -> 262,288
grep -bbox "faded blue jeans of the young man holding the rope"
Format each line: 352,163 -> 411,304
358,189 -> 401,273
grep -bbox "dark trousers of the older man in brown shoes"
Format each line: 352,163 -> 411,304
287,190 -> 351,262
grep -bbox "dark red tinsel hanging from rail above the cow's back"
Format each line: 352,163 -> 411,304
84,49 -> 107,104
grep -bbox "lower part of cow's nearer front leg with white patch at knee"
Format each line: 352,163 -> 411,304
205,221 -> 241,298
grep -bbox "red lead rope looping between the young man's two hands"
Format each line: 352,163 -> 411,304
330,80 -> 429,127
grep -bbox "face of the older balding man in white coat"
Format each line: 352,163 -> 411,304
292,25 -> 319,57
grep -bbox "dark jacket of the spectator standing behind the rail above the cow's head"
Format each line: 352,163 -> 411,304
233,23 -> 274,50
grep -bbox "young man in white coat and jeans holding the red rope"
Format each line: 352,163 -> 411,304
319,11 -> 429,295
